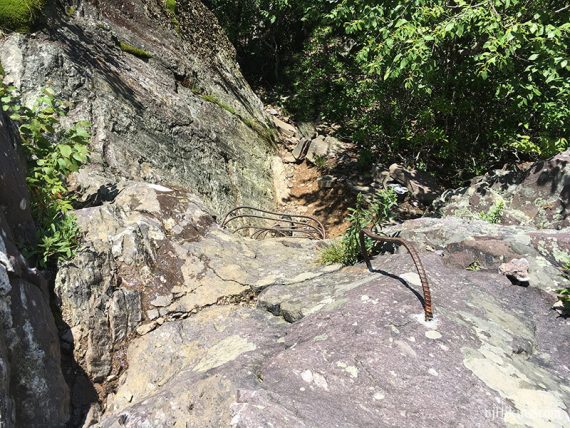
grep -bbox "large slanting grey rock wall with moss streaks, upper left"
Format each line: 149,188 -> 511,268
0,0 -> 273,214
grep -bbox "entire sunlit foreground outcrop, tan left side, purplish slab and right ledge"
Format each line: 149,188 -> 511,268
52,166 -> 570,428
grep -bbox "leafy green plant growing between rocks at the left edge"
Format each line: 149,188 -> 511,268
0,85 -> 90,266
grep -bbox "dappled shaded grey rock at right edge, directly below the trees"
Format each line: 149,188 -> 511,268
435,150 -> 570,229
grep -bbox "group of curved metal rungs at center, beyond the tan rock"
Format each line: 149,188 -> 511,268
222,205 -> 326,239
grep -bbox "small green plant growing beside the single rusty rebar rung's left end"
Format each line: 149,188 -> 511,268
319,188 -> 398,265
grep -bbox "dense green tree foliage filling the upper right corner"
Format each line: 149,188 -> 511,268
280,0 -> 570,178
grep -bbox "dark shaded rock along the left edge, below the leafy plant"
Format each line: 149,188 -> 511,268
0,113 -> 69,428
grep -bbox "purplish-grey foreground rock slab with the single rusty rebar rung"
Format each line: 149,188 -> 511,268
98,252 -> 570,428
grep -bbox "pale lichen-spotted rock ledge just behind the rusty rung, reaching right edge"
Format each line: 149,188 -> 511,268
385,217 -> 570,291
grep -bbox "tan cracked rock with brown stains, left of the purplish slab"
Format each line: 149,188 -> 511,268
55,169 -> 339,419
